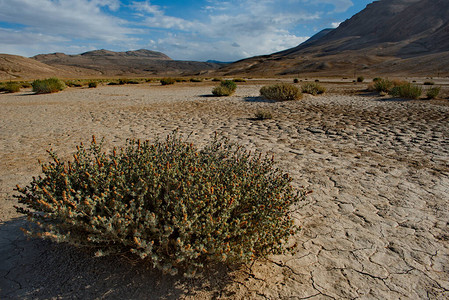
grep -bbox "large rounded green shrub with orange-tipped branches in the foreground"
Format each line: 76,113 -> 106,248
15,134 -> 305,275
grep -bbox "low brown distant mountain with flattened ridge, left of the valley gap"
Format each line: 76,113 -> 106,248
32,49 -> 220,76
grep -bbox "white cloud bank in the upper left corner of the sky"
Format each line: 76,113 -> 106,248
0,0 -> 131,42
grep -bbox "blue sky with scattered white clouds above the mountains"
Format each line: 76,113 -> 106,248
0,0 -> 373,61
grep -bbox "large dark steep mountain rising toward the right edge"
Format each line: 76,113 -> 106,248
220,0 -> 449,76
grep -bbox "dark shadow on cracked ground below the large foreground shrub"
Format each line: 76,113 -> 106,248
0,219 -> 236,299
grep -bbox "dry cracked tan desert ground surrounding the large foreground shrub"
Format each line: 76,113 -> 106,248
0,81 -> 449,299
